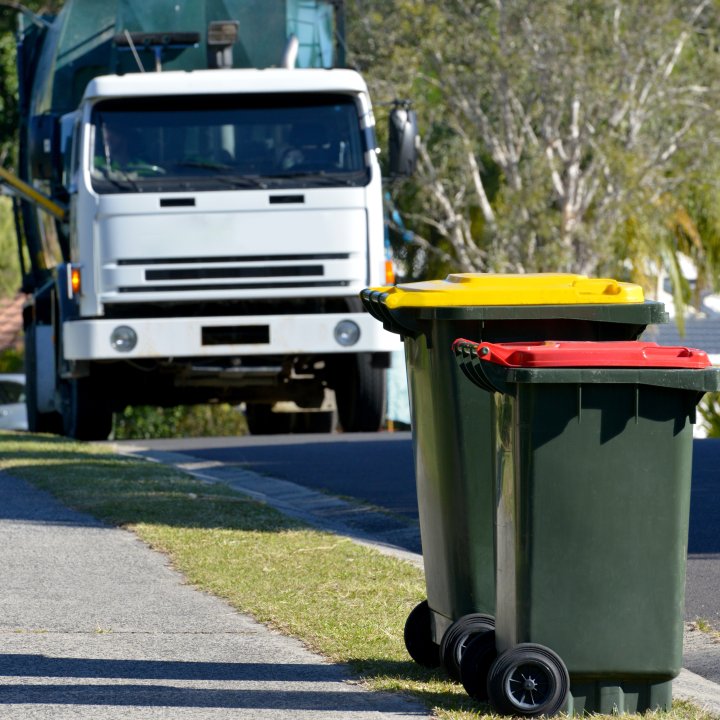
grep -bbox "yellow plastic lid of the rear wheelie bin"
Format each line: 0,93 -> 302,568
374,273 -> 645,309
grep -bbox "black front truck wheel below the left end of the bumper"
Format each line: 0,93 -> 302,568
60,377 -> 113,440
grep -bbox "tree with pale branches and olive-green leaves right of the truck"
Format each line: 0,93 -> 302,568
351,0 -> 720,300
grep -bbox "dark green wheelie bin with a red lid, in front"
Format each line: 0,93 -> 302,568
454,340 -> 720,716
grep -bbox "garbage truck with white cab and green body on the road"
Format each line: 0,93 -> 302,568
0,0 -> 416,440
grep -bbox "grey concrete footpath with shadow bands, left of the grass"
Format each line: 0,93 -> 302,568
0,473 -> 428,720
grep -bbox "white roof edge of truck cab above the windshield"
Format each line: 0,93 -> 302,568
84,68 -> 367,100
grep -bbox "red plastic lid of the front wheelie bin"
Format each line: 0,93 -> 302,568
470,340 -> 711,368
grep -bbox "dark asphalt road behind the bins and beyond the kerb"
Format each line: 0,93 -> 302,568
129,432 -> 720,629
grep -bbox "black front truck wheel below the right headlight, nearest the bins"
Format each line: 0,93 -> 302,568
335,353 -> 385,432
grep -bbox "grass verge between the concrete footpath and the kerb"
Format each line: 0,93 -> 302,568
0,433 -> 712,720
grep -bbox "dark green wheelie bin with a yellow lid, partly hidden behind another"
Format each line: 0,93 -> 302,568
361,273 -> 666,679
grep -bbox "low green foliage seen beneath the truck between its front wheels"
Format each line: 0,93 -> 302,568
114,404 -> 248,440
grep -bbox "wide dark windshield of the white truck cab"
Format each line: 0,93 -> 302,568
91,93 -> 374,194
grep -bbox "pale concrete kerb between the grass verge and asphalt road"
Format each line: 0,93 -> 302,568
116,444 -> 720,717
